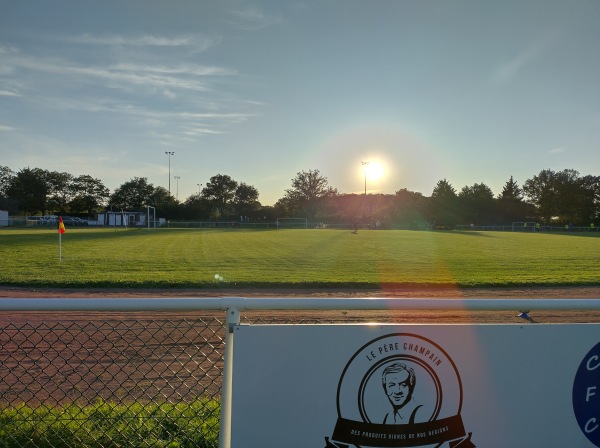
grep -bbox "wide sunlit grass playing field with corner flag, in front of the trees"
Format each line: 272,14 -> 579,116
0,229 -> 600,288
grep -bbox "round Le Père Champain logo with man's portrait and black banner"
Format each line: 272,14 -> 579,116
325,333 -> 475,448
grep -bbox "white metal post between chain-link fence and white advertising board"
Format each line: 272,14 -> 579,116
219,308 -> 240,448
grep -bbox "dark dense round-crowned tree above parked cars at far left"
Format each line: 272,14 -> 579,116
7,167 -> 48,215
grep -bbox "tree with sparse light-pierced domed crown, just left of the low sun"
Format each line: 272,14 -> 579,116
280,170 -> 338,221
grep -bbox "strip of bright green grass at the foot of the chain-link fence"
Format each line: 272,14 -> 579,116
0,400 -> 220,448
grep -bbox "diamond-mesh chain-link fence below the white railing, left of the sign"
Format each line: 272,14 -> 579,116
0,311 -> 368,448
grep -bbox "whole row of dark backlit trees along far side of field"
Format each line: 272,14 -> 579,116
0,165 -> 600,227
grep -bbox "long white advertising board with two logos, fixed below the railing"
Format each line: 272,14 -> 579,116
231,324 -> 600,448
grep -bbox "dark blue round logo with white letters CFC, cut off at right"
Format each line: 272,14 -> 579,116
573,342 -> 600,447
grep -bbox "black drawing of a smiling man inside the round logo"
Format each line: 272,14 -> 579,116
381,362 -> 421,425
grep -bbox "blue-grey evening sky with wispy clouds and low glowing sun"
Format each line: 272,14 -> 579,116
0,0 -> 600,205
